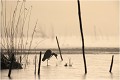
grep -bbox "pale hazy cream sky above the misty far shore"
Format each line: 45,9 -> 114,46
0,0 -> 119,47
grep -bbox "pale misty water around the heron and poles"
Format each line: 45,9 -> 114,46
0,51 -> 120,80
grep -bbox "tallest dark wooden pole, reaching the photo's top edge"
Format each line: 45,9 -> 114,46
78,0 -> 87,73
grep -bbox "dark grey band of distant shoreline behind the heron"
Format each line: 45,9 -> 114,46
3,47 -> 120,54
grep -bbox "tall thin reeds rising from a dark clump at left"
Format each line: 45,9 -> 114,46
1,0 -> 37,69
